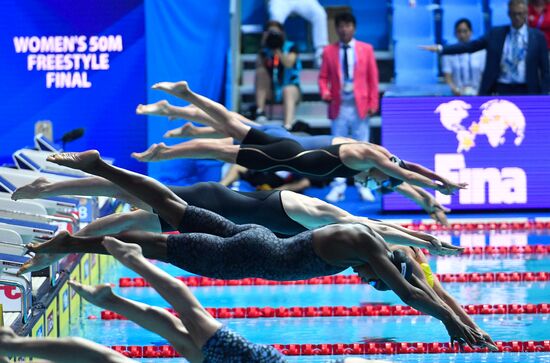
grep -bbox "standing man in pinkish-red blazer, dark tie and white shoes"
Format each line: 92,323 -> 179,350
319,13 -> 378,202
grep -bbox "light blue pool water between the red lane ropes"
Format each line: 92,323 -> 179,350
71,236 -> 550,363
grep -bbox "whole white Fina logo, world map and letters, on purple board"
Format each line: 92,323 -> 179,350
434,99 -> 527,205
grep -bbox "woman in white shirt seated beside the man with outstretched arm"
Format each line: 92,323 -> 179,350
442,18 -> 485,96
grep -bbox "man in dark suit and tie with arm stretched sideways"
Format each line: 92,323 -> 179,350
421,0 -> 550,95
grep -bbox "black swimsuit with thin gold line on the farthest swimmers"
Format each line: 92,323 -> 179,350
237,128 -> 361,178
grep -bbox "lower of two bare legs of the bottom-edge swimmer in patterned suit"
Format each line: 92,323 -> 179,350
69,278 -> 202,361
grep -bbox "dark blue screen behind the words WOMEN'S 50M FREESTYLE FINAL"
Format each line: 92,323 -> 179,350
0,0 -> 146,171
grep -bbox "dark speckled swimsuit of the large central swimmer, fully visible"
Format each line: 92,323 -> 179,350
167,206 -> 345,281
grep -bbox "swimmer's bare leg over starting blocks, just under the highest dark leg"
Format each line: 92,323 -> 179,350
11,177 -> 151,210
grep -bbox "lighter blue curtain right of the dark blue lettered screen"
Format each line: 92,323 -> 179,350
144,0 -> 229,183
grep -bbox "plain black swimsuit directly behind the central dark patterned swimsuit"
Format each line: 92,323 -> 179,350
159,182 -> 307,236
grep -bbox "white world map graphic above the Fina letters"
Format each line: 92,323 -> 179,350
434,99 -> 525,153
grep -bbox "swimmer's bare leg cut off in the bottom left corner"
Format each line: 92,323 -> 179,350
0,327 -> 136,363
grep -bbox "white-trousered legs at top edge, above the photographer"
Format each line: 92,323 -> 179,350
269,0 -> 328,68
